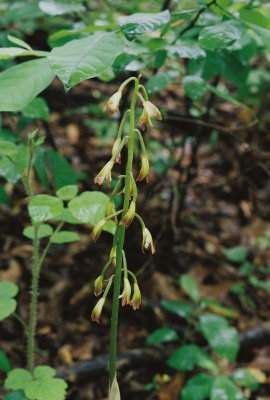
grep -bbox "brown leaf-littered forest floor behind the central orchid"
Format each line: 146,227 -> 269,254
0,76 -> 270,400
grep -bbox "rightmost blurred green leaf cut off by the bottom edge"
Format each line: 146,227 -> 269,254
210,375 -> 246,400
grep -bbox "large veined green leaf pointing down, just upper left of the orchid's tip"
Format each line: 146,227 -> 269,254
48,32 -> 124,91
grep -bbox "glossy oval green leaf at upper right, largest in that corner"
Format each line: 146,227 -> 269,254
199,20 -> 245,51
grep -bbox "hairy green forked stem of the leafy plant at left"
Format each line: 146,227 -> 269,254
27,222 -> 64,373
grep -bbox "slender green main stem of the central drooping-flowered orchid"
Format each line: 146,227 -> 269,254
109,78 -> 139,386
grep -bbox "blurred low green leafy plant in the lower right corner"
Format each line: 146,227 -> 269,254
146,275 -> 259,400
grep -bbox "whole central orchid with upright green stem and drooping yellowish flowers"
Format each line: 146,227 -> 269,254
91,77 -> 162,400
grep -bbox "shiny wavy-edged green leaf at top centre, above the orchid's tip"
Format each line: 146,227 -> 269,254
118,10 -> 170,39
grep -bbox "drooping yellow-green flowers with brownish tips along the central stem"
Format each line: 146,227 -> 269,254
91,78 -> 162,323
